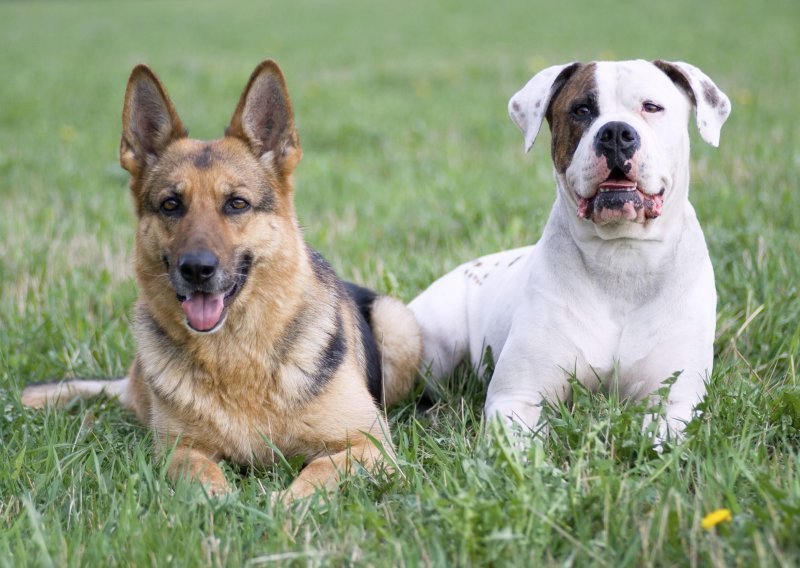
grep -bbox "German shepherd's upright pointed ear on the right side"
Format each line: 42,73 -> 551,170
225,59 -> 303,176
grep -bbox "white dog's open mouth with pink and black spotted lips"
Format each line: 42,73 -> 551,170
578,170 -> 664,225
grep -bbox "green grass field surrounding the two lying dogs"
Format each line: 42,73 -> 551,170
0,0 -> 800,567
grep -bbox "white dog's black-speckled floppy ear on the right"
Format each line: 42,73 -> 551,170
653,61 -> 731,147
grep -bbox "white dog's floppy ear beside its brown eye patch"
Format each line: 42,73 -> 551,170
508,63 -> 580,152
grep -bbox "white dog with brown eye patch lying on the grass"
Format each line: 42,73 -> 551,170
411,61 -> 731,437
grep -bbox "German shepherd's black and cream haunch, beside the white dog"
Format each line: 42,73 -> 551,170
345,282 -> 422,408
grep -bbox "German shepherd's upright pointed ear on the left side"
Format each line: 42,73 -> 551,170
119,65 -> 186,176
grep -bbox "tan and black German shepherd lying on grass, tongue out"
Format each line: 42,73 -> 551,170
22,60 -> 421,501
